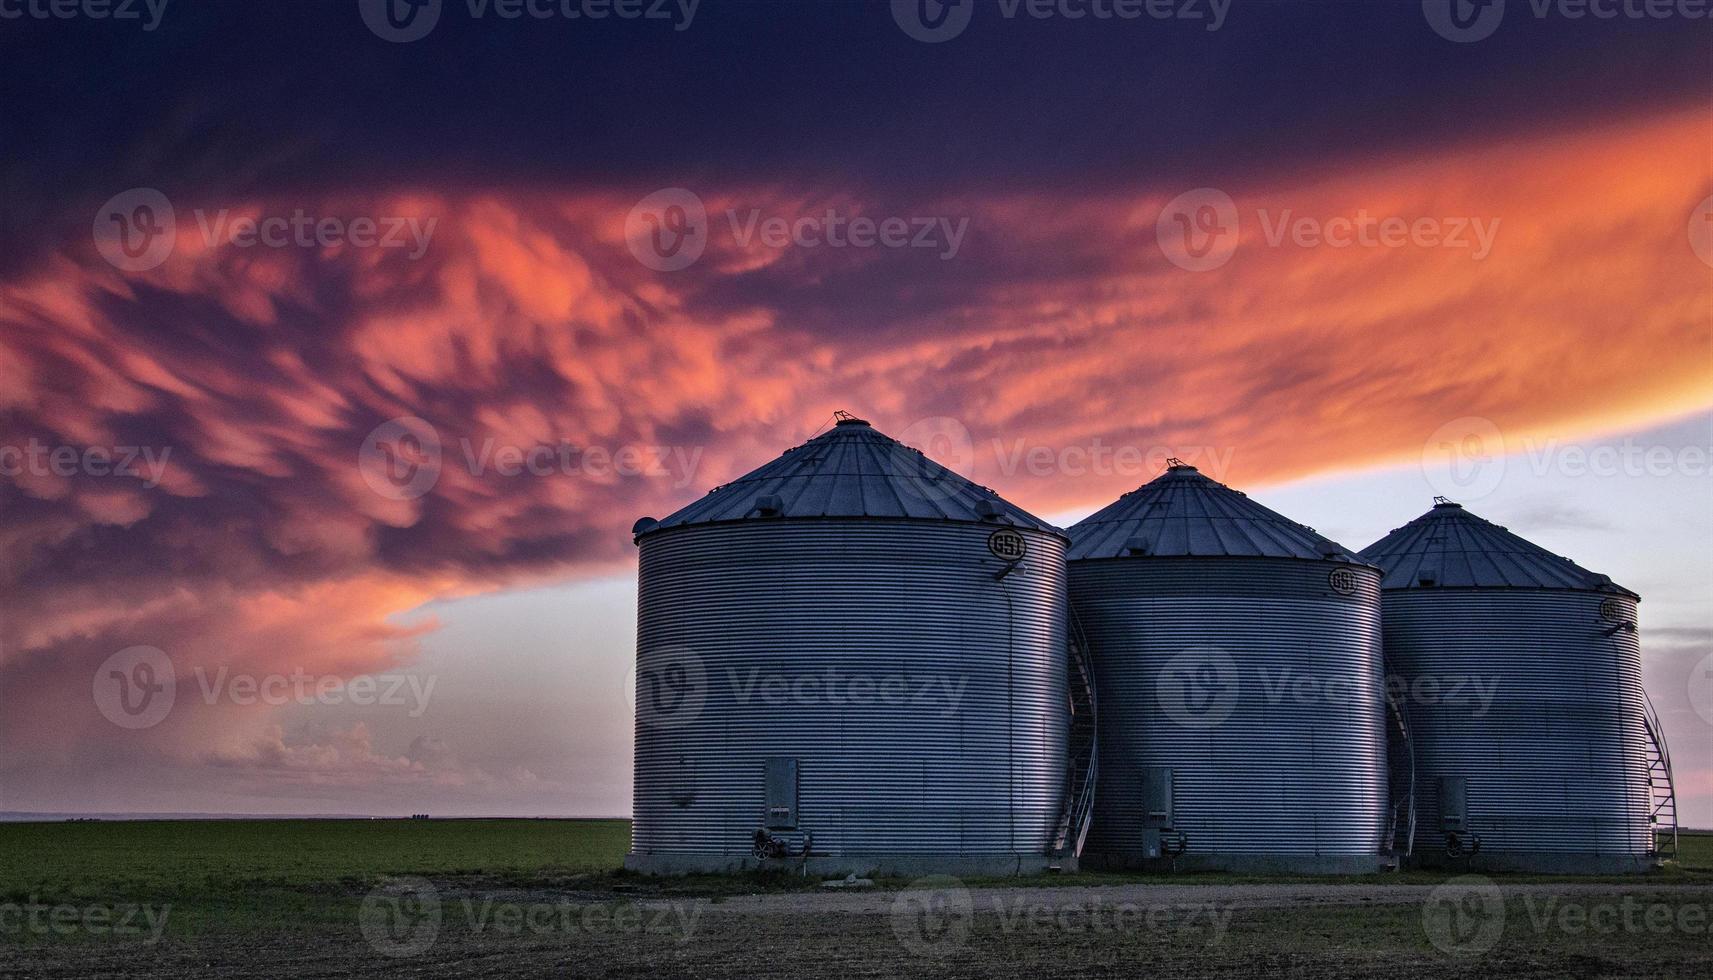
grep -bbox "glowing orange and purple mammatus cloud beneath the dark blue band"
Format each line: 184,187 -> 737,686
0,105 -> 1713,809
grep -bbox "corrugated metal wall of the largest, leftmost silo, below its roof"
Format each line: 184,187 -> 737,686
632,519 -> 1067,855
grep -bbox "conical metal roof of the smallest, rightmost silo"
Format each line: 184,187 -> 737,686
1362,497 -> 1636,596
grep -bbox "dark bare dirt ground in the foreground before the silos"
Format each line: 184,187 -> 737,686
0,879 -> 1713,980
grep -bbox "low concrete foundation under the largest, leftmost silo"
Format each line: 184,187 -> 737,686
625,853 -> 1077,877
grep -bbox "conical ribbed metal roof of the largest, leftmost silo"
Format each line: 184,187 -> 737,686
634,416 -> 1064,536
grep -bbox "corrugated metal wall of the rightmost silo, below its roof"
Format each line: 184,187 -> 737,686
1384,588 -> 1651,855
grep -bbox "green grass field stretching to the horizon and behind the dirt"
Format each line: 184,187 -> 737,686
0,821 -> 1713,941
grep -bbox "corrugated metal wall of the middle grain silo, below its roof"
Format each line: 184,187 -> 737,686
1069,557 -> 1388,857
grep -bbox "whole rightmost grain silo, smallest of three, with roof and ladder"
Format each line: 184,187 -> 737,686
1362,499 -> 1675,872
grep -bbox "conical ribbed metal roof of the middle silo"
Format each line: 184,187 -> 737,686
1065,461 -> 1360,562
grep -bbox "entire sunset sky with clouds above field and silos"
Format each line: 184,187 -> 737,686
0,0 -> 1713,826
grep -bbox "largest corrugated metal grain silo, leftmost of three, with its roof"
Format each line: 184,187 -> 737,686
627,416 -> 1069,874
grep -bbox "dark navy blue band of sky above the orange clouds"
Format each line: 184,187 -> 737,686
0,0 -> 1713,272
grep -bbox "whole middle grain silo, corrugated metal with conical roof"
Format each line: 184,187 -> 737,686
1069,461 -> 1393,872
